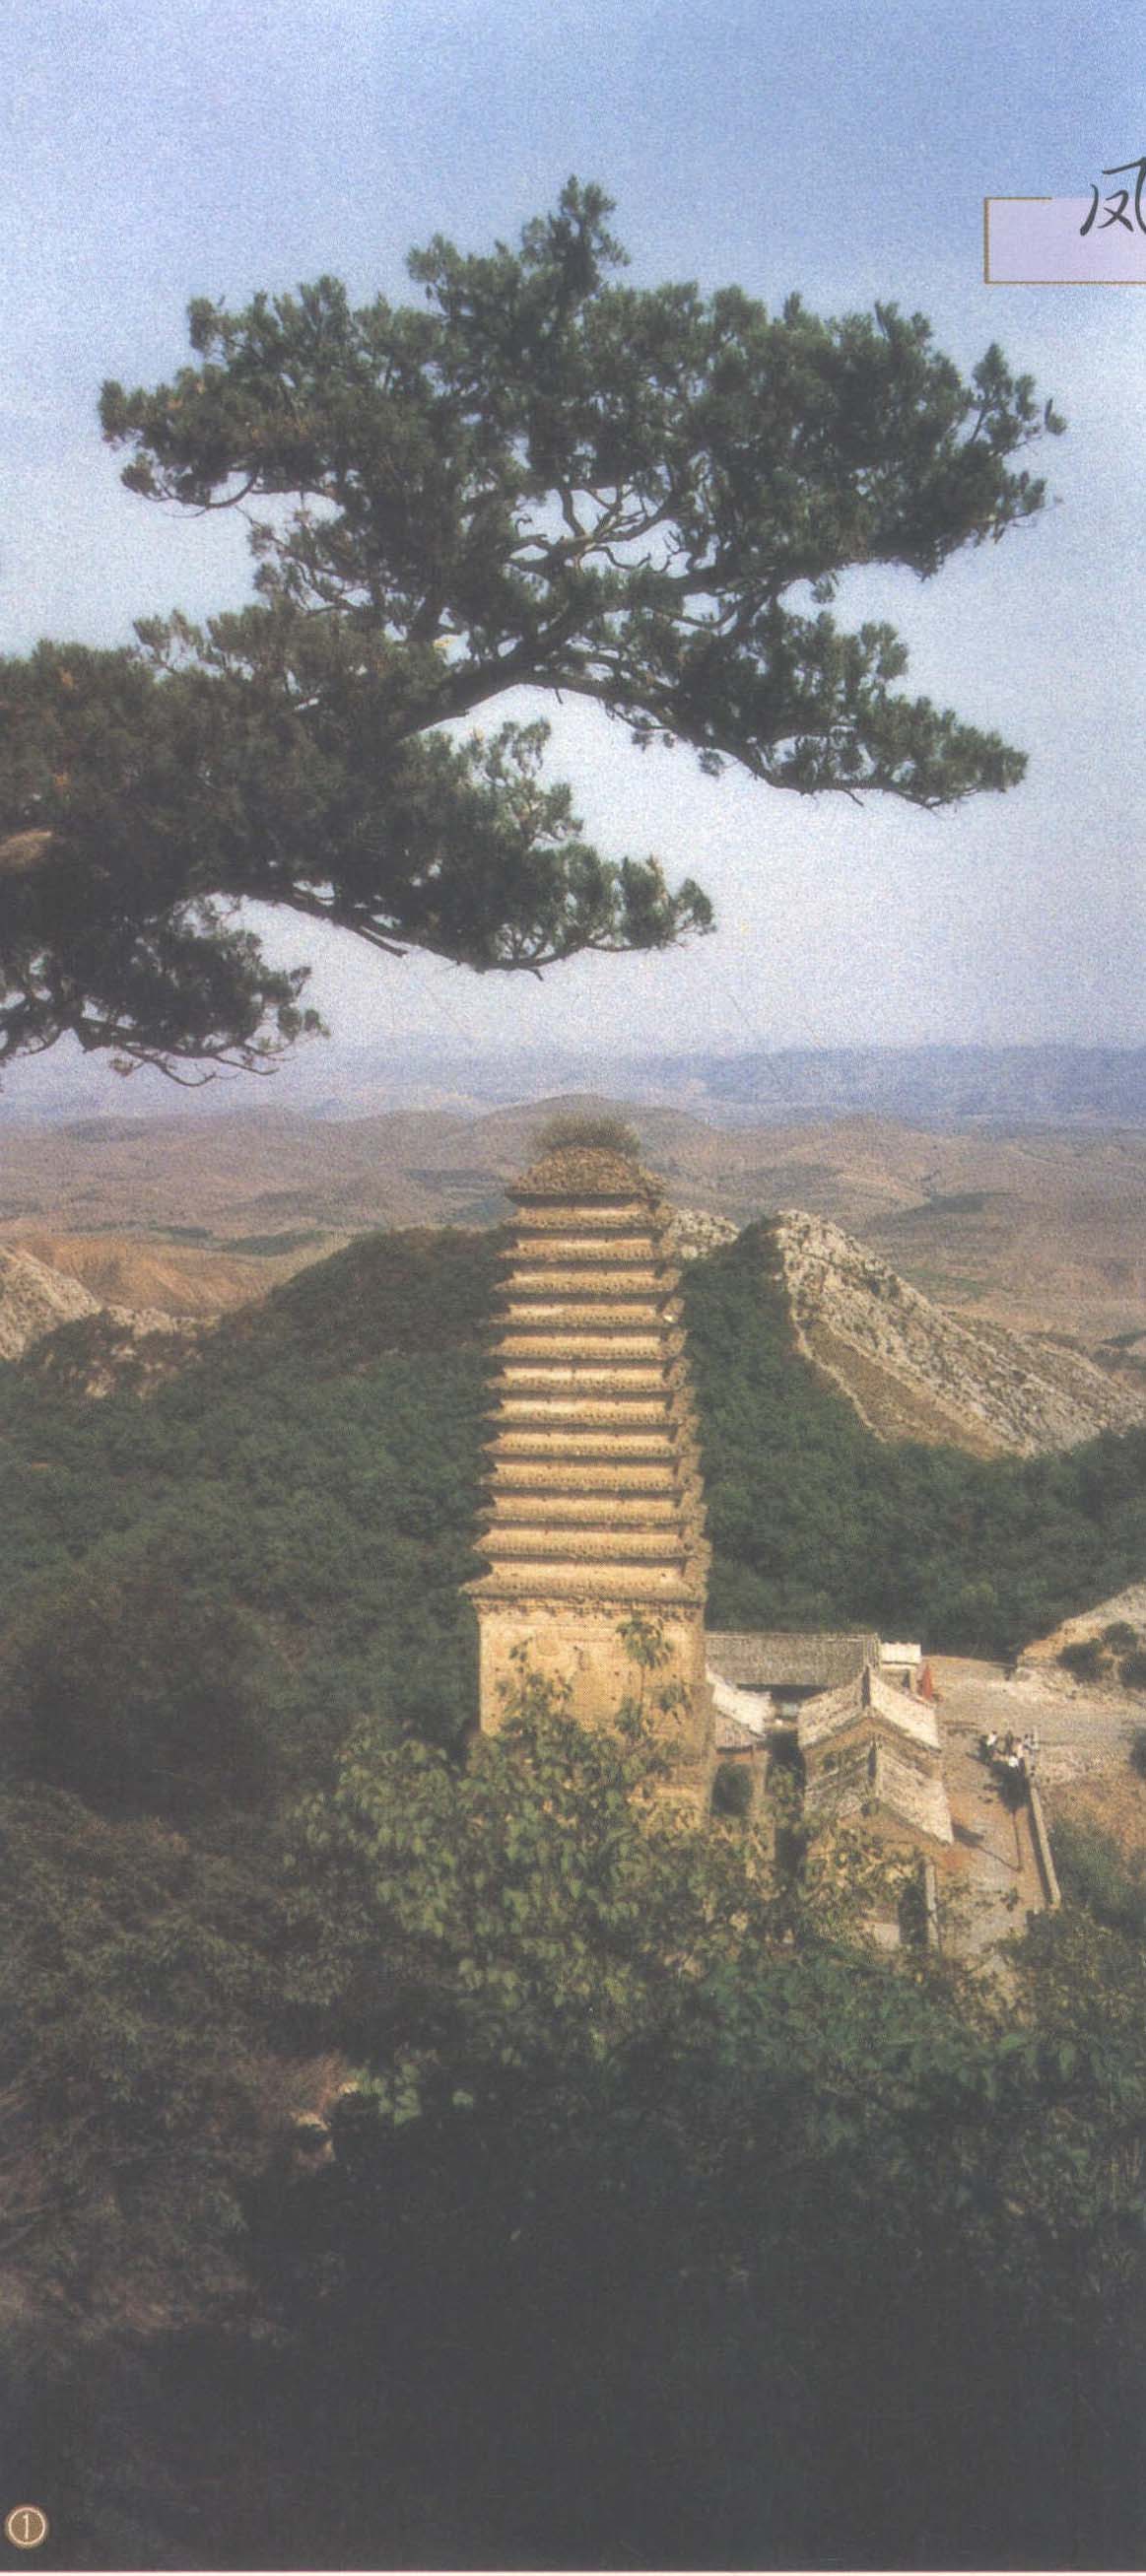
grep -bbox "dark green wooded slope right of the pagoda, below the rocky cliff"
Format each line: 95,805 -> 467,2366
685,1226 -> 1146,1654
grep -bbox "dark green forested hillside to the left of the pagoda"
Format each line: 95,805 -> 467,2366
0,1234 -> 495,1813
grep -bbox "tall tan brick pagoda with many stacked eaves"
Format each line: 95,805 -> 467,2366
469,1144 -> 713,1796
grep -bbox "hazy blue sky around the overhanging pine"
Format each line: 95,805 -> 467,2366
0,0 -> 1146,1108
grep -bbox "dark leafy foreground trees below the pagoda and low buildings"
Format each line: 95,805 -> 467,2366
8,1695 -> 1146,2568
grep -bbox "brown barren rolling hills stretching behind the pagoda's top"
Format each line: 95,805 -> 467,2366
0,1081 -> 1146,1360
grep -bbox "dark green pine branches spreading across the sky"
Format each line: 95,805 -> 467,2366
0,180 -> 1061,1069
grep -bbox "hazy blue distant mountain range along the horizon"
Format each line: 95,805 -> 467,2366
11,1041 -> 1146,1131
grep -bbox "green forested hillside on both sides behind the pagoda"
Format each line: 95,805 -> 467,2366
0,1226 -> 1146,1721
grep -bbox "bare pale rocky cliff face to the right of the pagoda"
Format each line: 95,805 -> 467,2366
775,1208 -> 1146,1458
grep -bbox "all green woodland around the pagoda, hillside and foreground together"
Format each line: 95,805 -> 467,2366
0,1229 -> 1146,2568
